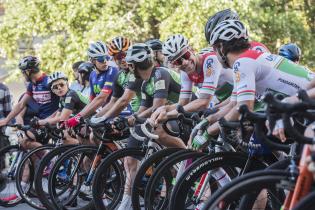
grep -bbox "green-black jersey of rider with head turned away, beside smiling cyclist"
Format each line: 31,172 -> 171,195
141,67 -> 180,107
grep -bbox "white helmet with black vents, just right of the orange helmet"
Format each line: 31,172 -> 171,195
126,43 -> 153,63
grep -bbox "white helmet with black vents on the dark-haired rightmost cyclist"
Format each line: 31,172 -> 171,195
210,20 -> 248,45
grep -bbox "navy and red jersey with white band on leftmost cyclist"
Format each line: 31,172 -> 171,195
26,74 -> 59,119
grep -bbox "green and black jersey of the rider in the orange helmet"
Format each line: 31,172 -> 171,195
113,70 -> 143,112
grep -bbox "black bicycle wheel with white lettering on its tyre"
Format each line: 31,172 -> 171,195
169,152 -> 266,209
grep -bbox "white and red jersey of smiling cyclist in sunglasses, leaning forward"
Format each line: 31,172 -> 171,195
180,52 -> 233,101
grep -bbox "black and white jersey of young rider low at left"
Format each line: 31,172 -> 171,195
59,90 -> 89,115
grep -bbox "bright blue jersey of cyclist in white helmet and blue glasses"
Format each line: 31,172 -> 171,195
90,66 -> 118,100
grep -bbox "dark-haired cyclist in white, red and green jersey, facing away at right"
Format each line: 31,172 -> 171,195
192,20 -> 312,149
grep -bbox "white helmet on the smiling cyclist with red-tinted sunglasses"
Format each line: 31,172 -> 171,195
162,34 -> 189,61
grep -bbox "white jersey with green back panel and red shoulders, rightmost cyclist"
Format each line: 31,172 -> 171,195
231,50 -> 313,108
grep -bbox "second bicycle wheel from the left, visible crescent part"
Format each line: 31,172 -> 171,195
16,145 -> 54,209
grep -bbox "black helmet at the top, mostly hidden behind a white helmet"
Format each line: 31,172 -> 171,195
205,9 -> 239,43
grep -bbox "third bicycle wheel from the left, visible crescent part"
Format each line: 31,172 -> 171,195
35,145 -> 76,210
